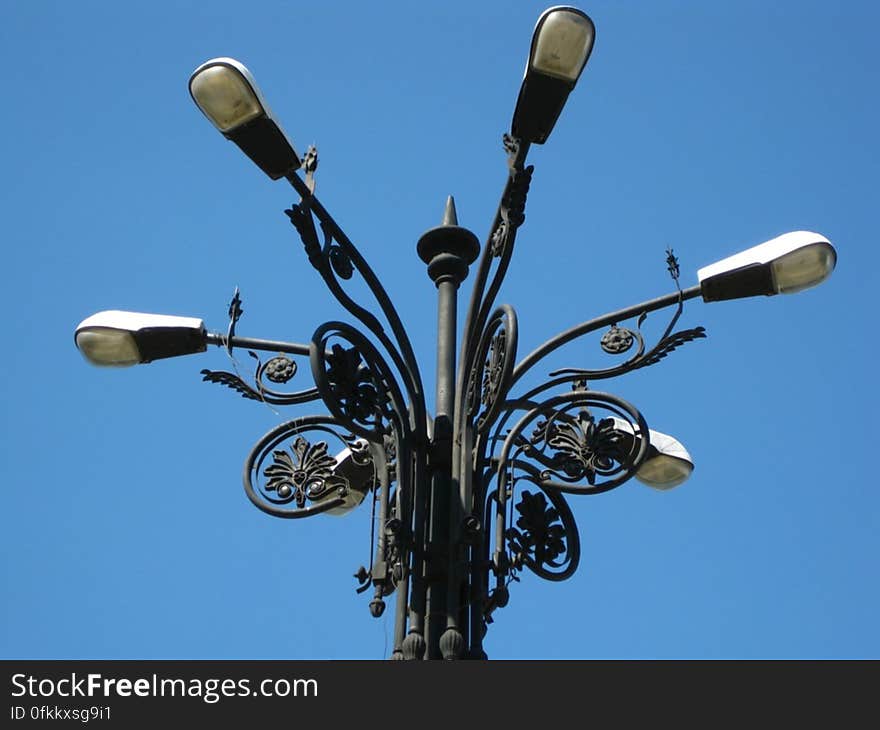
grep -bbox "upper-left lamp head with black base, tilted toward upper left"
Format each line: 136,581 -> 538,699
189,58 -> 301,180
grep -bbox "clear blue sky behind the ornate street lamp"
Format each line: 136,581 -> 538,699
0,0 -> 880,659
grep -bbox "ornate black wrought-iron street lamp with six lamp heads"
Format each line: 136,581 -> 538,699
75,7 -> 836,659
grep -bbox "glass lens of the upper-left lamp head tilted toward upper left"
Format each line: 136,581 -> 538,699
190,64 -> 265,132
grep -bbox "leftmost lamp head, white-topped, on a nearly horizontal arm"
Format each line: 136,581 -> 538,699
74,311 -> 207,367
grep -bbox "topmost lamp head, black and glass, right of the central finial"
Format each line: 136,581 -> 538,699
511,6 -> 596,144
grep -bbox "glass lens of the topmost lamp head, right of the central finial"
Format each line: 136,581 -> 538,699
532,10 -> 594,83
